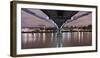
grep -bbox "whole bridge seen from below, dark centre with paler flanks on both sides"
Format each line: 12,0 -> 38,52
22,8 -> 91,29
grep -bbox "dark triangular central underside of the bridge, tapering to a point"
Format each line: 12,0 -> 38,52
42,9 -> 78,28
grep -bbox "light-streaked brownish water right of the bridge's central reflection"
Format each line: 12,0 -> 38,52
63,32 -> 92,47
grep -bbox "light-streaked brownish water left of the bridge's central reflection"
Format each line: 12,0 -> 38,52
22,33 -> 57,49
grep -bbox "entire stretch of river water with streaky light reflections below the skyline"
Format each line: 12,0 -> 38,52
21,32 -> 92,49
